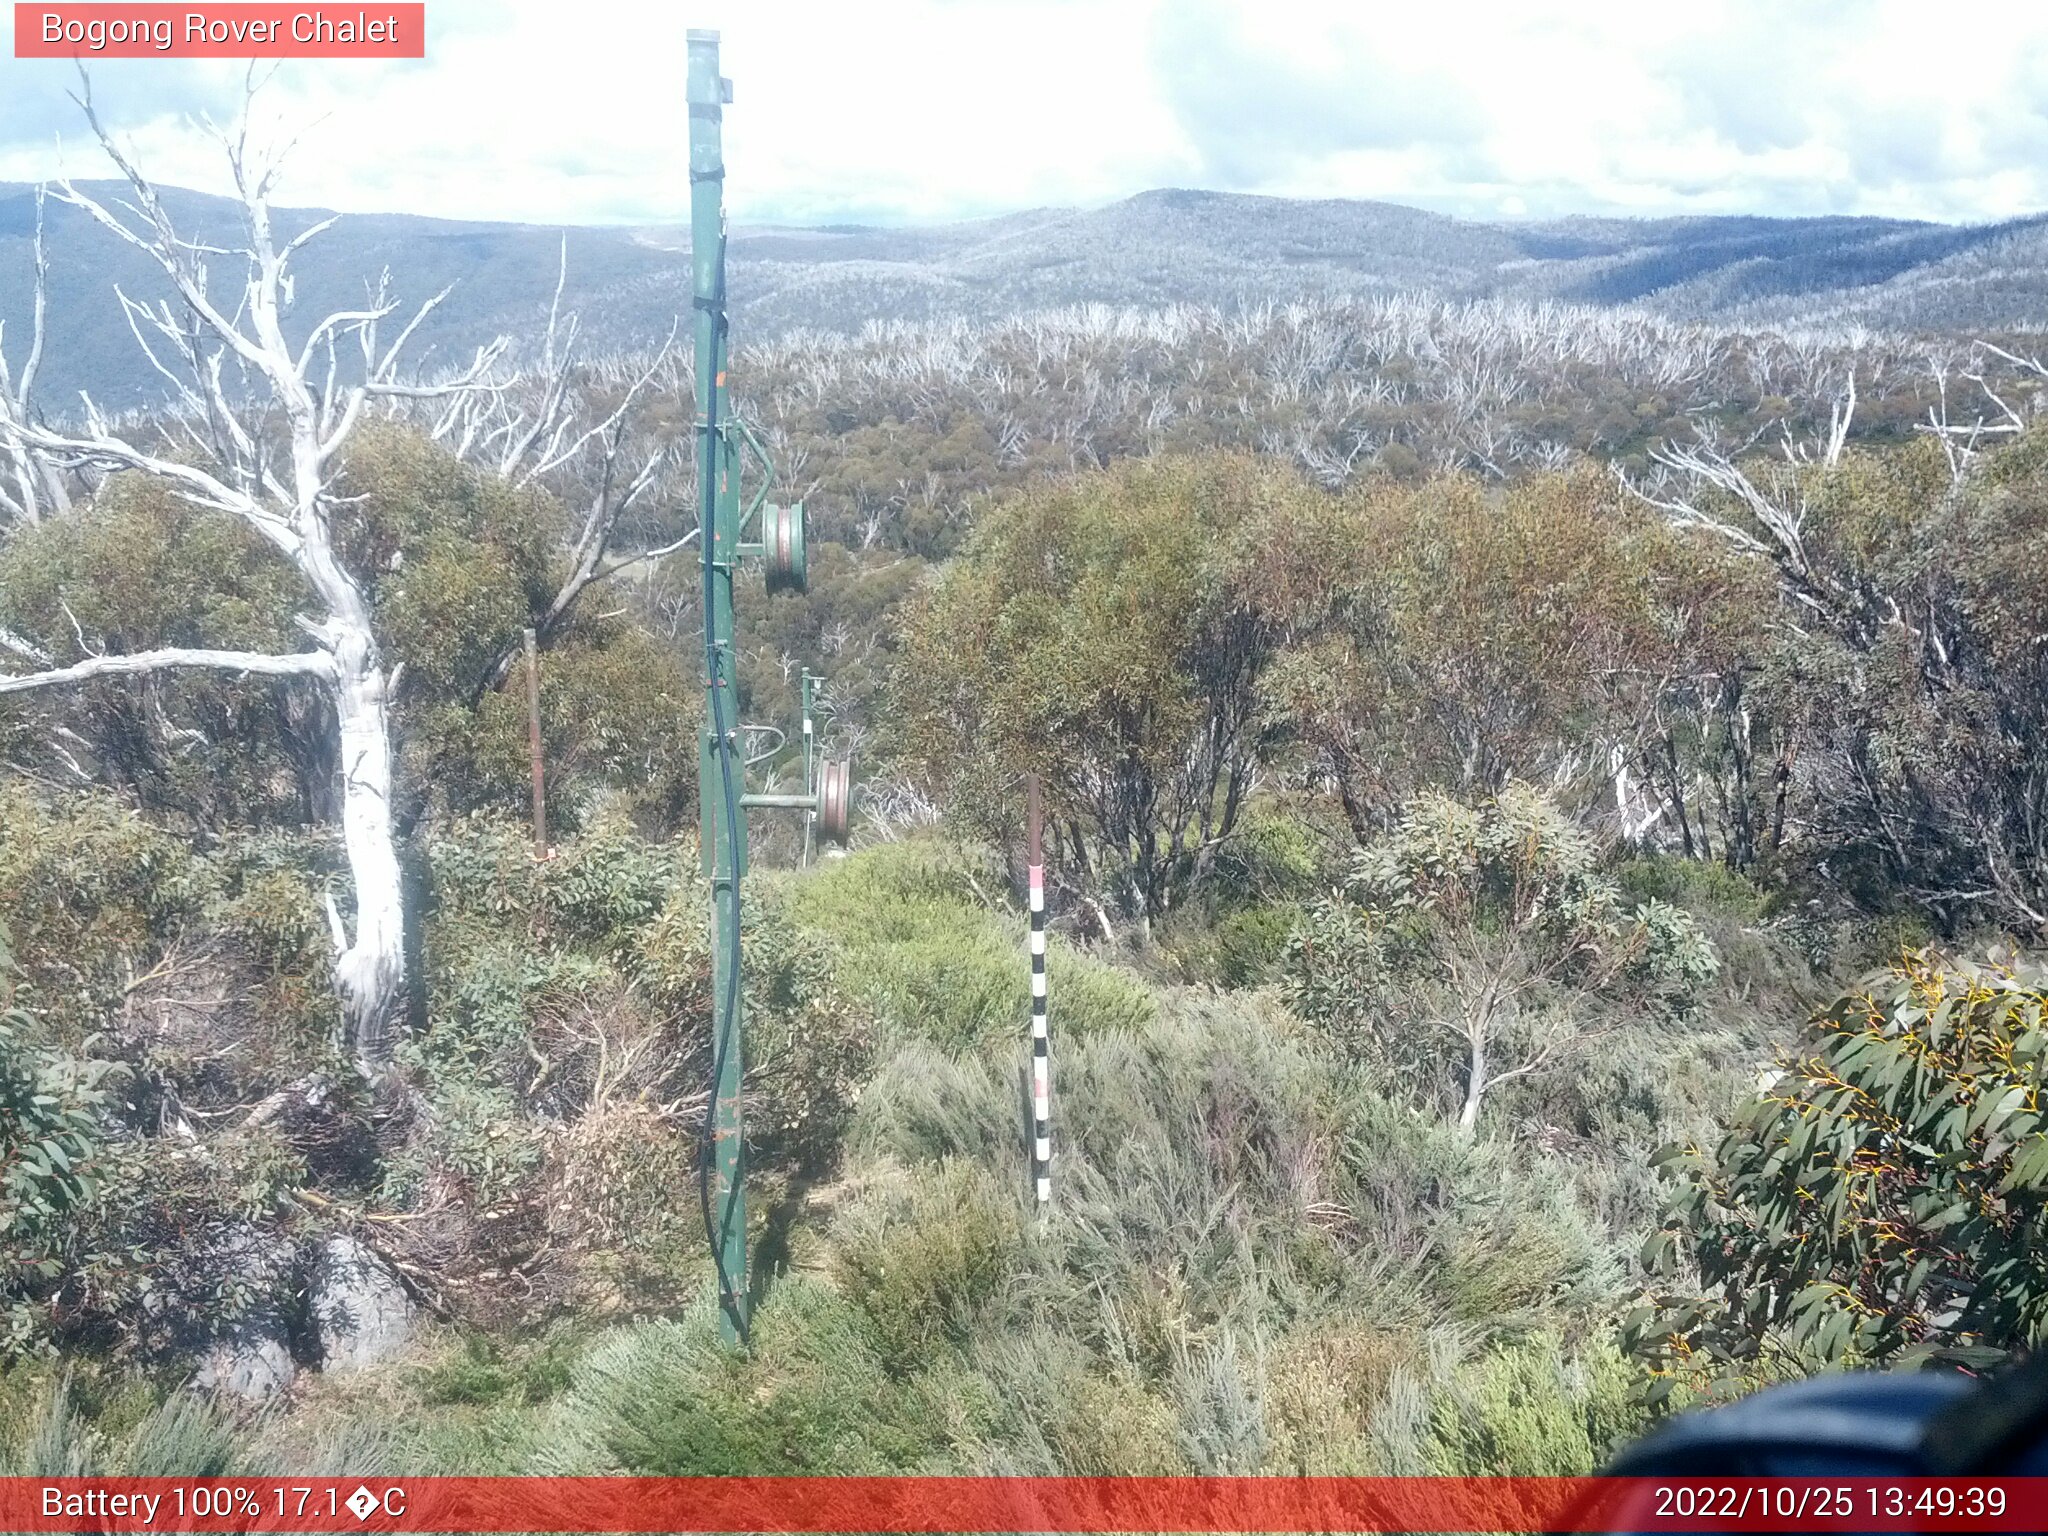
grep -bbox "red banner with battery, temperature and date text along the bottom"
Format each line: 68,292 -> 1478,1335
12,1477 -> 2048,1532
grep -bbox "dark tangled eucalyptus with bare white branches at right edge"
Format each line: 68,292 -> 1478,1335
1624,393 -> 2048,934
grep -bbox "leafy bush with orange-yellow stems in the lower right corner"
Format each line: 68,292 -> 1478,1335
1630,950 -> 2048,1391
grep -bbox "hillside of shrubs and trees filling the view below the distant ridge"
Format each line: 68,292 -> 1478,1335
0,147 -> 2048,1475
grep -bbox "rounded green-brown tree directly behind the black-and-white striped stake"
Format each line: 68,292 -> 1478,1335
895,455 -> 1327,926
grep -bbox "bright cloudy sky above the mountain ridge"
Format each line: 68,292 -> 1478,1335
0,0 -> 2048,223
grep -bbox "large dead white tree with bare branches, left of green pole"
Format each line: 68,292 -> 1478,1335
0,80 -> 504,1071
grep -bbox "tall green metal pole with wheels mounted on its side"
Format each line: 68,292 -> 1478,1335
688,31 -> 748,1341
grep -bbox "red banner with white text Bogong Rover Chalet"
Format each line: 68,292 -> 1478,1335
14,0 -> 426,61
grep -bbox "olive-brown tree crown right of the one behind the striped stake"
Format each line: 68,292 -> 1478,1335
1272,471 -> 1772,842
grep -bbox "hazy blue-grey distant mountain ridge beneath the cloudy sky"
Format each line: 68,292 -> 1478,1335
0,182 -> 2048,412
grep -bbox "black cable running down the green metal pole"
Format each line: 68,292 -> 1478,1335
696,227 -> 752,1346
